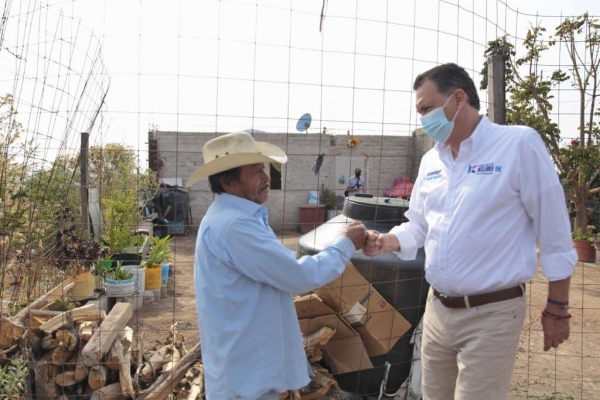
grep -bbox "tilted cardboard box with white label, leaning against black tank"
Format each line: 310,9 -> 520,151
315,262 -> 411,357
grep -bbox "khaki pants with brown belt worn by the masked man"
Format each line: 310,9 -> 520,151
421,290 -> 527,400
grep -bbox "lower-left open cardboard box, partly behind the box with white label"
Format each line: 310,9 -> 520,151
294,294 -> 373,374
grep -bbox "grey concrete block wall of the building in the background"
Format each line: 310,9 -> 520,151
149,131 -> 427,230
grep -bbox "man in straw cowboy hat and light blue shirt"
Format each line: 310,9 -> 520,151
187,132 -> 366,400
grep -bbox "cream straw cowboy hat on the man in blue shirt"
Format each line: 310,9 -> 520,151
185,132 -> 287,187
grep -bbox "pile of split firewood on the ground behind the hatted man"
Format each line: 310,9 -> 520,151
0,281 -> 340,400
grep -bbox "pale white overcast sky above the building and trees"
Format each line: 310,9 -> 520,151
0,0 -> 600,164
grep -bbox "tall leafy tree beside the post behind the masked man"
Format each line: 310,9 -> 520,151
481,13 -> 600,234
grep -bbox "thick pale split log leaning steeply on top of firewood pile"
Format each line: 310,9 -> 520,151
81,303 -> 133,367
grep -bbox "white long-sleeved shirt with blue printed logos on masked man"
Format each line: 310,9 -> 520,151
390,116 -> 577,296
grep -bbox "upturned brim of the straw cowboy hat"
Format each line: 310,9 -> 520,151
185,142 -> 287,187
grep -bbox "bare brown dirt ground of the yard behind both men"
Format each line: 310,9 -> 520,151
130,231 -> 600,400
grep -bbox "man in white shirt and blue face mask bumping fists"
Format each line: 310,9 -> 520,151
363,64 -> 577,400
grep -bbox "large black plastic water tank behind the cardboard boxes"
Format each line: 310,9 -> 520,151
298,197 -> 429,395
